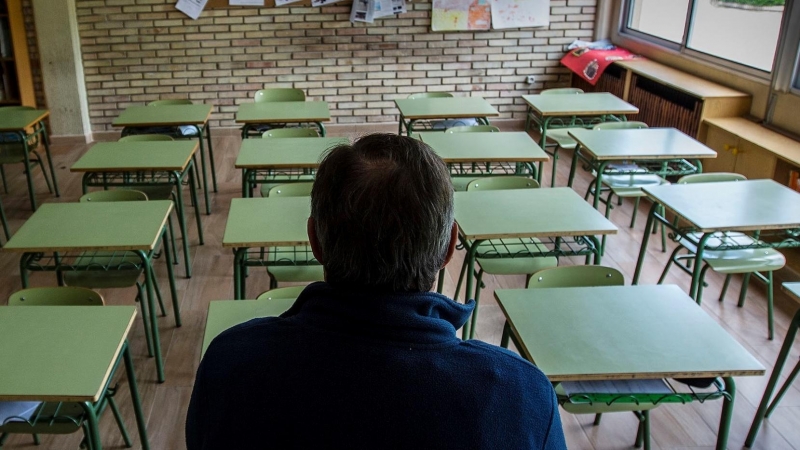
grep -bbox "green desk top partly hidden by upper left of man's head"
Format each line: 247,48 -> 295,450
235,137 -> 350,169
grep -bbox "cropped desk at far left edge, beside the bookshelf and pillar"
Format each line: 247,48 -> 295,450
0,109 -> 61,211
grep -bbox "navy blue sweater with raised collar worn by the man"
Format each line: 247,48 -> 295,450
186,283 -> 566,450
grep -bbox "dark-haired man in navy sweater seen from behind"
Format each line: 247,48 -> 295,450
186,134 -> 566,450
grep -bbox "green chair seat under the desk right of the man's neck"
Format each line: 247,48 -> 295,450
477,239 -> 558,275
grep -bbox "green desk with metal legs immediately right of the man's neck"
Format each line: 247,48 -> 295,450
455,187 -> 617,338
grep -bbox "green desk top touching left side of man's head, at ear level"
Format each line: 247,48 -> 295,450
225,197 -> 311,248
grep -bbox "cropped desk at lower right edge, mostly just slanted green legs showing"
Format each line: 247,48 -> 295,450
744,283 -> 800,448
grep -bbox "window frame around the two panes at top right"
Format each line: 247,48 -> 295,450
618,0 -> 788,80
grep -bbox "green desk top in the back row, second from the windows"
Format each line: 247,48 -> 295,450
394,97 -> 500,119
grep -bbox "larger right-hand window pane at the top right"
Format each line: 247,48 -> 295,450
686,0 -> 783,72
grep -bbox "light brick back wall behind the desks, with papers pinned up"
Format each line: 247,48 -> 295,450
76,0 -> 596,131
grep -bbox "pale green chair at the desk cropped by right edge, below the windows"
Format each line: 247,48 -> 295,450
658,173 -> 786,340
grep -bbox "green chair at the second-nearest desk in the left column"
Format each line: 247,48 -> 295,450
63,189 -> 180,356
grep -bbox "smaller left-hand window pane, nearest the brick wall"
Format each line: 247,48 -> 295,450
628,0 -> 692,44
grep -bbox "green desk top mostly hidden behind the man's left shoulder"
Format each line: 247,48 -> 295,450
200,298 -> 295,358
